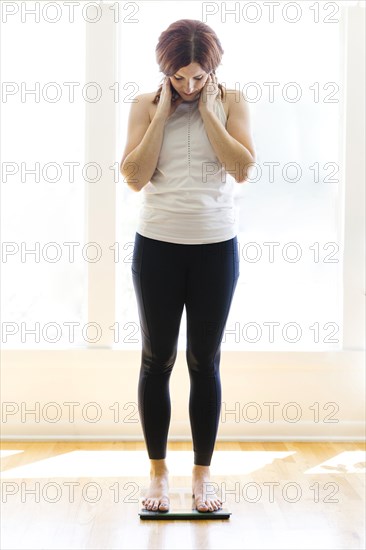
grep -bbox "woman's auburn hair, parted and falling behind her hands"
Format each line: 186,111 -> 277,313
152,19 -> 225,103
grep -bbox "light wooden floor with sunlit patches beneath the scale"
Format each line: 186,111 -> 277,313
1,442 -> 365,550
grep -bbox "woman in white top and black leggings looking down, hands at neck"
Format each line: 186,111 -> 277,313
121,19 -> 255,512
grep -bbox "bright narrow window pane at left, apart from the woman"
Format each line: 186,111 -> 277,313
1,6 -> 87,349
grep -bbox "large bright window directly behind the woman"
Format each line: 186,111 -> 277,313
116,2 -> 343,351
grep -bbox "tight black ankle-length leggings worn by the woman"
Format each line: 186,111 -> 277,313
131,233 -> 239,466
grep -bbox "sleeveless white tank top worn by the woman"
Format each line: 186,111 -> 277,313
137,97 -> 238,244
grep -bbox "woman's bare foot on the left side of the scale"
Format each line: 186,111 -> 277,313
142,459 -> 169,512
